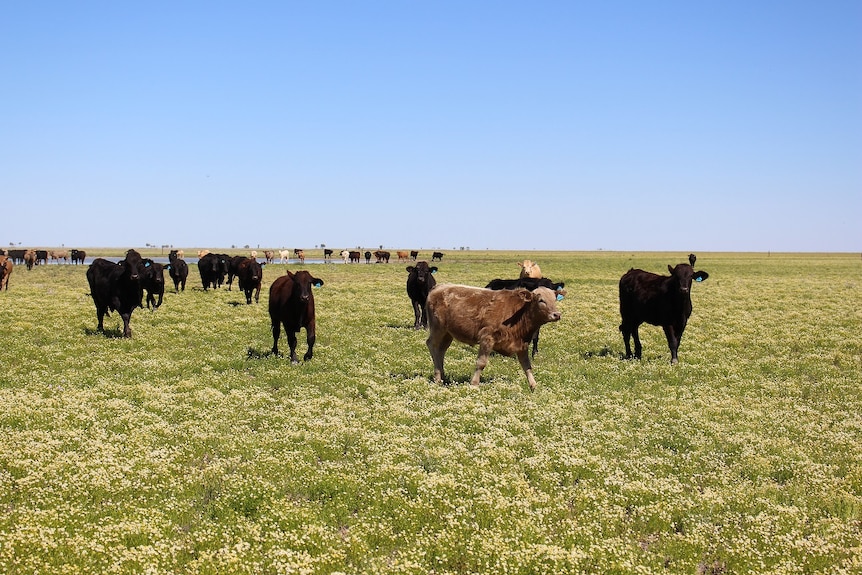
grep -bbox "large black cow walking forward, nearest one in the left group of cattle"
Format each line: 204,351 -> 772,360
87,250 -> 143,337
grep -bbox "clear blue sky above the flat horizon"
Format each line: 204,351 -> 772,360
0,0 -> 862,253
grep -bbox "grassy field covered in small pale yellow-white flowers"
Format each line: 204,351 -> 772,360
0,253 -> 862,575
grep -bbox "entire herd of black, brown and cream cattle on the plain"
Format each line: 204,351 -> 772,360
0,250 -> 709,390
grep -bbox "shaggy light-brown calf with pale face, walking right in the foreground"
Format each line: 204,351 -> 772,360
425,284 -> 560,390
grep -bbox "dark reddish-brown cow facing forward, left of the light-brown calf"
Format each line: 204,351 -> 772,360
269,270 -> 323,363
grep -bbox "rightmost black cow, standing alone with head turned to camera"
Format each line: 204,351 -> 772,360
620,264 -> 709,364
